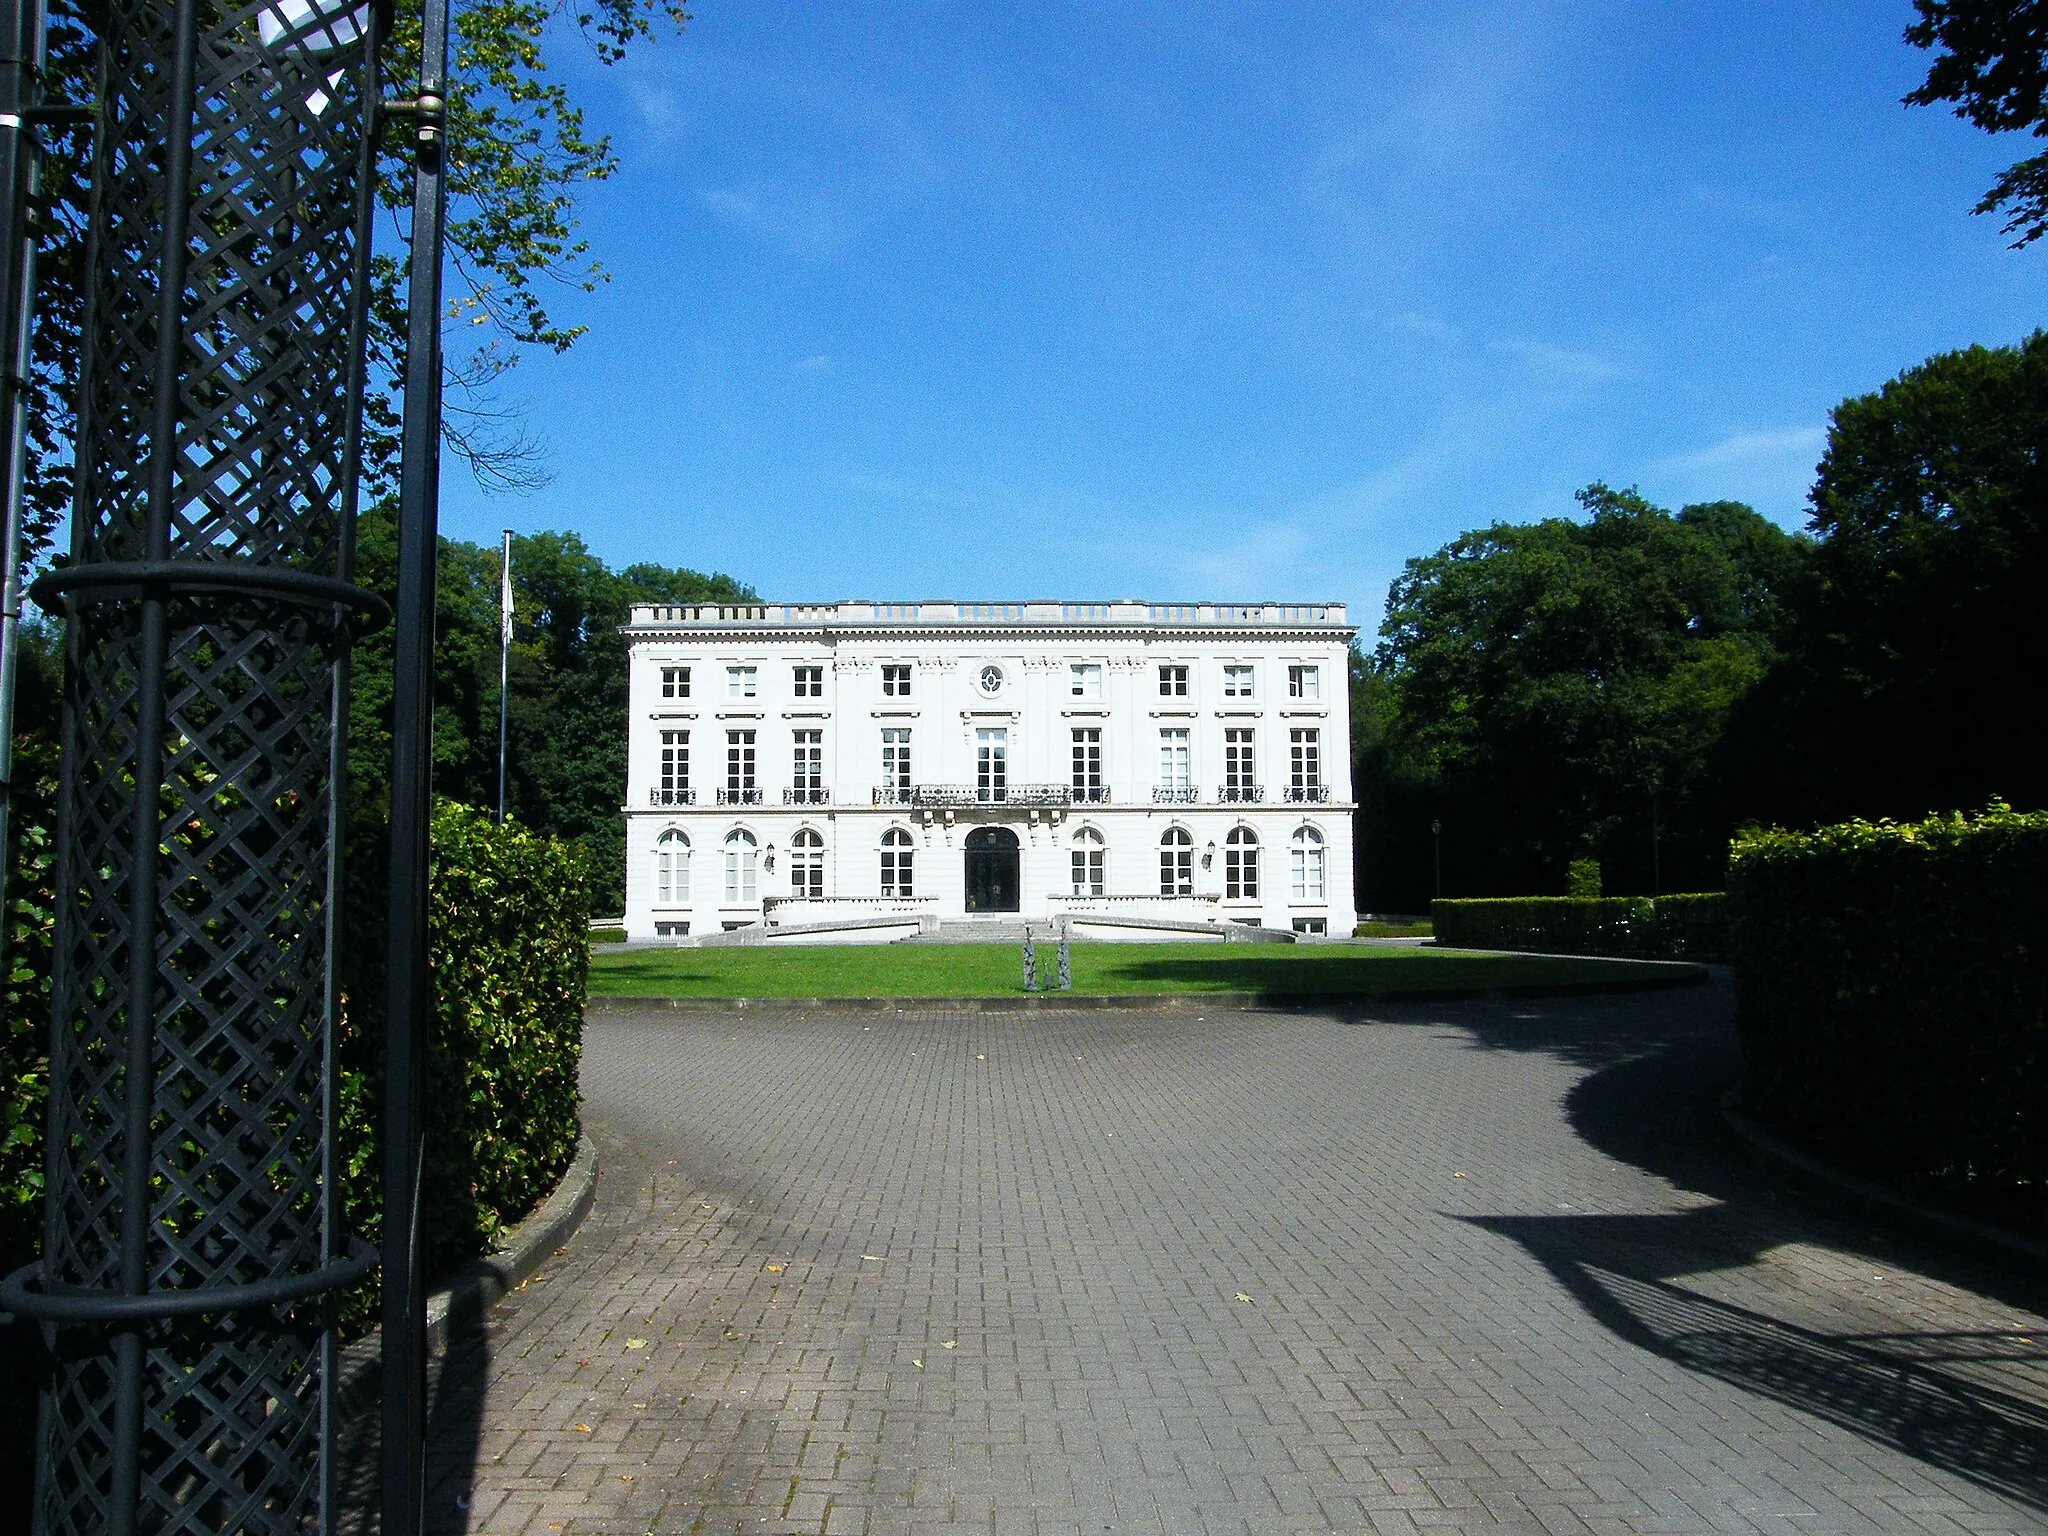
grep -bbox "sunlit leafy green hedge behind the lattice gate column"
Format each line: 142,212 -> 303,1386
0,797 -> 590,1321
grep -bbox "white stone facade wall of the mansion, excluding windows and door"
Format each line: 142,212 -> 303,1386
625,602 -> 1356,938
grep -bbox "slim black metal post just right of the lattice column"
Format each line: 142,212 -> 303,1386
383,0 -> 449,1536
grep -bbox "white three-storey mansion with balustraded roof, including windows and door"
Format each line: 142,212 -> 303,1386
625,602 -> 1354,938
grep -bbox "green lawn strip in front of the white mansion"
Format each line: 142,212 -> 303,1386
590,944 -> 1698,997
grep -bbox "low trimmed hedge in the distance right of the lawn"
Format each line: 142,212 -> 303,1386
1430,891 -> 1729,961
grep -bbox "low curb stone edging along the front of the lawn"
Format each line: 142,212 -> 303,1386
584,963 -> 1708,1018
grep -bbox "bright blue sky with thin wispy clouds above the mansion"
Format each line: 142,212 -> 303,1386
442,0 -> 2048,633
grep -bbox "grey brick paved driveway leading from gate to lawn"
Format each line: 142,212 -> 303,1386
411,987 -> 2048,1536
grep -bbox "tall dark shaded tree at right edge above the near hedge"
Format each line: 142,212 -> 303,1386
1731,332 -> 2048,823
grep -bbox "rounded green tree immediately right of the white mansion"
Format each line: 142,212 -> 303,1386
1360,483 -> 1804,905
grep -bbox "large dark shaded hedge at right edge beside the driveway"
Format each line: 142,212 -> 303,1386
1729,805 -> 2048,1204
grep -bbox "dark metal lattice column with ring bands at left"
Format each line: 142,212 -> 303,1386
6,0 -> 381,1536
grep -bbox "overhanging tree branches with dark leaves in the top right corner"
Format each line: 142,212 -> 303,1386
1907,0 -> 2048,250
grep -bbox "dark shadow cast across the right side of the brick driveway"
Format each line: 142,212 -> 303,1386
1413,981 -> 2048,1509
